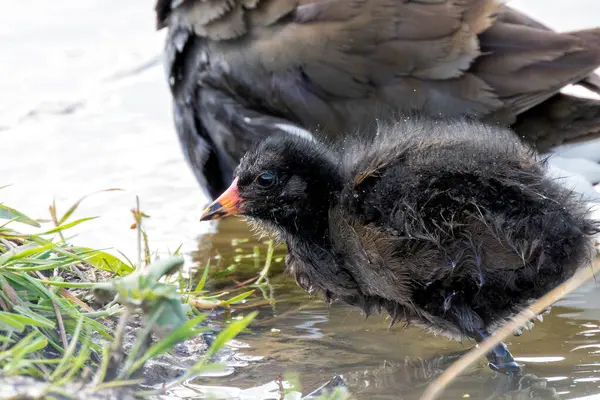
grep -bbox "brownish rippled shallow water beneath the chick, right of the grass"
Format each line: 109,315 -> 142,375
169,219 -> 600,399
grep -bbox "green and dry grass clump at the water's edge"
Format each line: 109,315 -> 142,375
0,190 -> 255,398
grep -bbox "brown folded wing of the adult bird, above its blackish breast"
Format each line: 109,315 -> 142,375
157,0 -> 600,125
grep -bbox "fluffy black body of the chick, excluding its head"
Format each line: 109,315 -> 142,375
338,123 -> 596,338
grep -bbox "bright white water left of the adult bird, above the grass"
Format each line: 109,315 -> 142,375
0,0 -> 206,258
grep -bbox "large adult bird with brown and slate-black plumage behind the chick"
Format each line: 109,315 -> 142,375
156,0 -> 600,198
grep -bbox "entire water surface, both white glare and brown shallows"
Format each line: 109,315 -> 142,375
0,0 -> 600,399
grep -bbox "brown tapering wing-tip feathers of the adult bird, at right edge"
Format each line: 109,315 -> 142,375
472,22 -> 600,116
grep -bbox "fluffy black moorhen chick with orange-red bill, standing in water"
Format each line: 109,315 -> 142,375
201,119 -> 599,370
